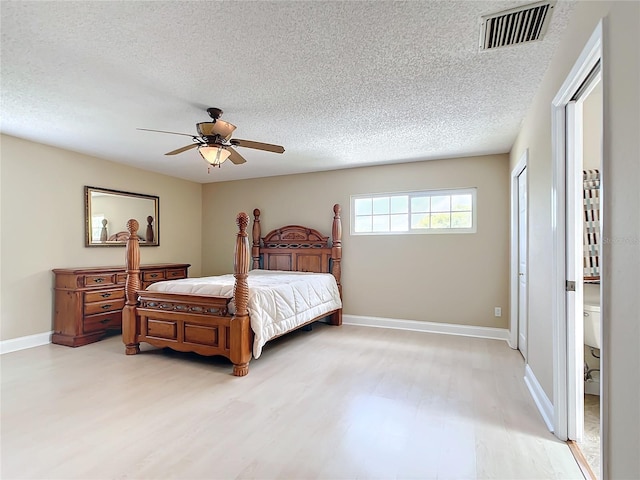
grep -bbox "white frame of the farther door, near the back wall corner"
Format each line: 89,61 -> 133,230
509,148 -> 529,349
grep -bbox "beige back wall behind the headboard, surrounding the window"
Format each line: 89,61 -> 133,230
202,155 -> 509,328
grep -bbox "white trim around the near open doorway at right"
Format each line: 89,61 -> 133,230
551,21 -> 602,440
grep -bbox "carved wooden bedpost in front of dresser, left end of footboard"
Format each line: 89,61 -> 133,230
122,219 -> 140,355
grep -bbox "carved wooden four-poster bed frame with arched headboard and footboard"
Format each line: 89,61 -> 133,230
122,205 -> 342,376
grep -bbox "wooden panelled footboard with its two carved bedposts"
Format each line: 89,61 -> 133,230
122,213 -> 253,376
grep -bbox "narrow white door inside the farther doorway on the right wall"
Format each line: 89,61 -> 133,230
518,167 -> 527,360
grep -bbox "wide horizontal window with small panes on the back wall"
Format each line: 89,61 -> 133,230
351,188 -> 476,235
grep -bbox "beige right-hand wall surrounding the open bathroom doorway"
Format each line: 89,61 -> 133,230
511,2 -> 640,479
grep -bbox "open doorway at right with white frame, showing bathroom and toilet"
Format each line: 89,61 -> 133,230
552,20 -> 606,478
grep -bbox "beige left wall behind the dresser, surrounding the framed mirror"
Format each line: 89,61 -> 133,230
0,135 -> 202,340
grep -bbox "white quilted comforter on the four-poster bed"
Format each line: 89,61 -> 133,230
147,270 -> 342,358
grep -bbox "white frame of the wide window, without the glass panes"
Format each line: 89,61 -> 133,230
350,187 -> 478,236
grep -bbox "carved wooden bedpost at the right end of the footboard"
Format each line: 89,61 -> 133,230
230,212 -> 255,377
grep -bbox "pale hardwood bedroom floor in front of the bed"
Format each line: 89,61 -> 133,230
1,324 -> 583,480
